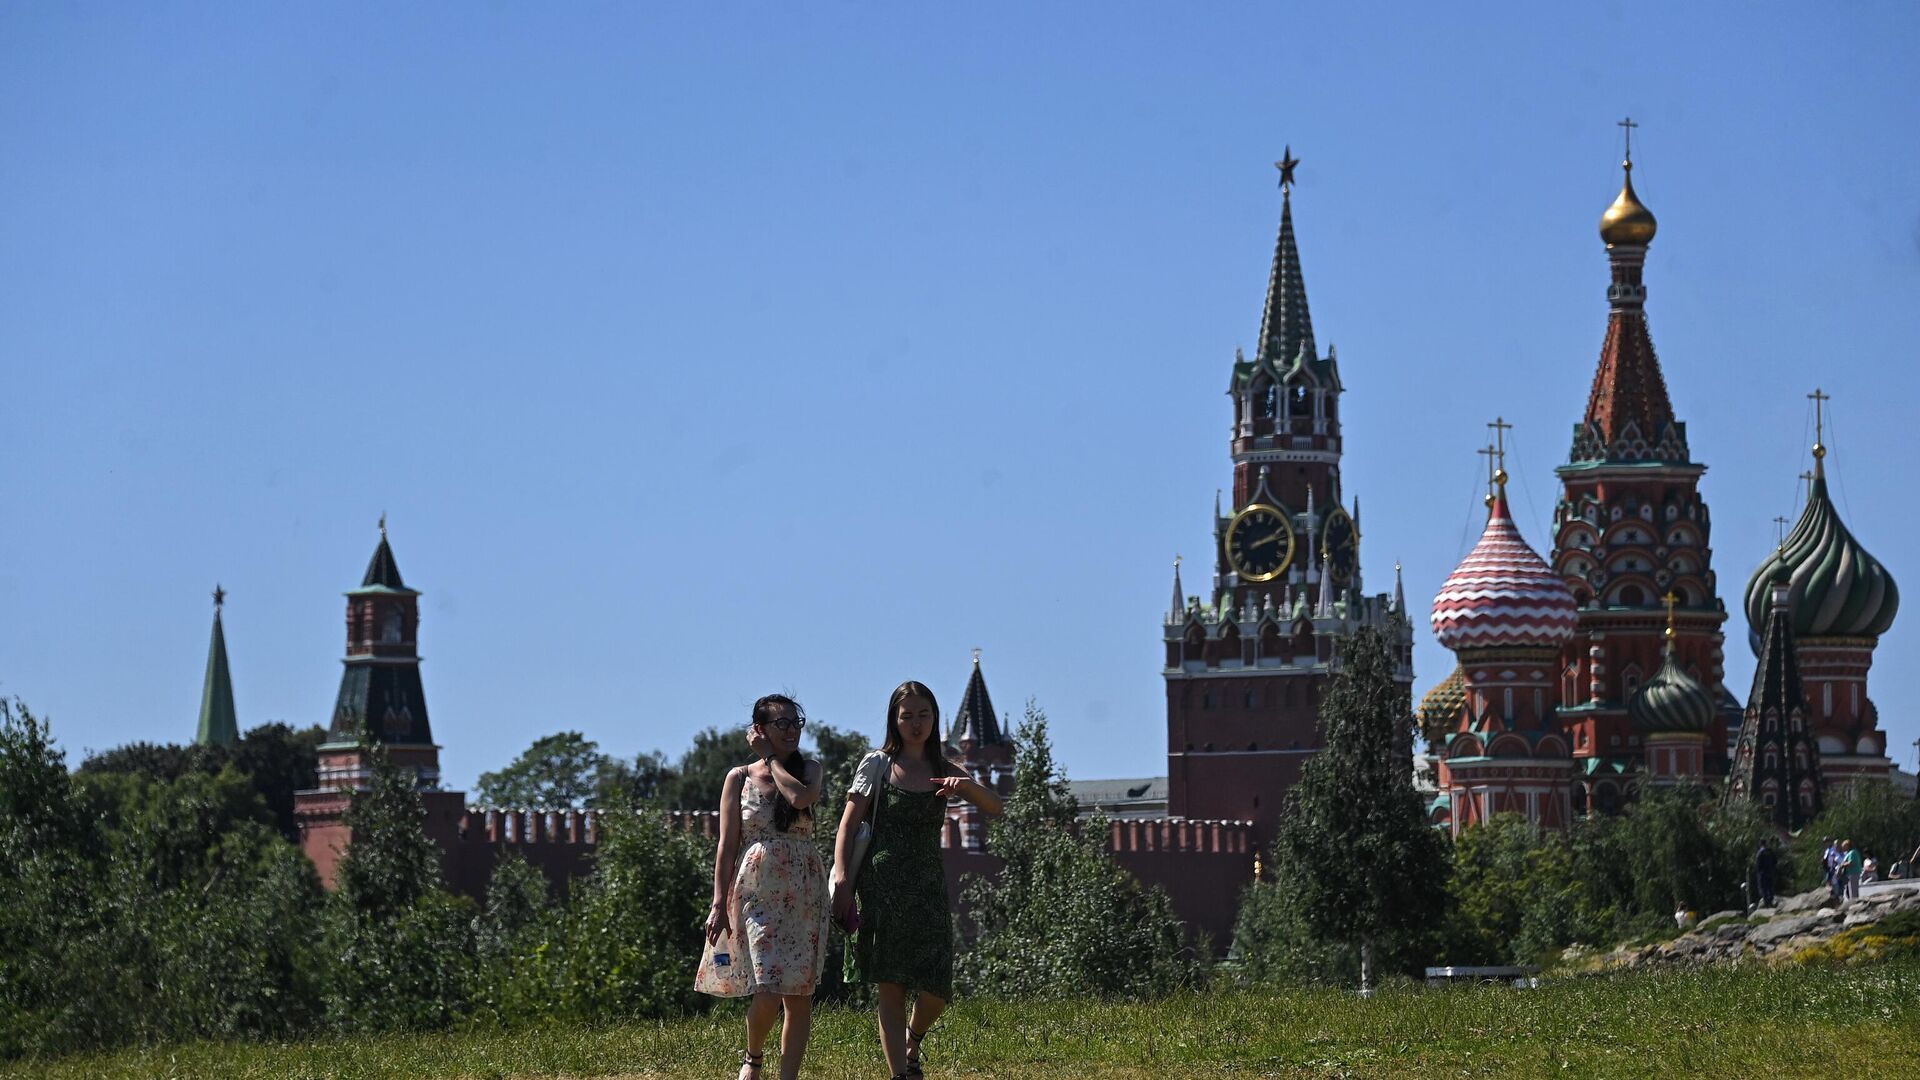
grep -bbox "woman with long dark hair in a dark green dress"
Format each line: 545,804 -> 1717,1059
833,682 -> 1000,1080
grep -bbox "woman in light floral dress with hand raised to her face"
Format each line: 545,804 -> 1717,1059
693,694 -> 828,1080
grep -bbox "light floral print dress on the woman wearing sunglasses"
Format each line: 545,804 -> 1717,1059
693,776 -> 828,997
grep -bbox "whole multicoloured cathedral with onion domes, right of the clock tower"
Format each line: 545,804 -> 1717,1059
1421,141 -> 1899,834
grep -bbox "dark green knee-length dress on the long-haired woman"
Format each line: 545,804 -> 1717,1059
845,782 -> 954,999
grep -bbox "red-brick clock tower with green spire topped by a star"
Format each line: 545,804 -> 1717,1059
1162,150 -> 1413,844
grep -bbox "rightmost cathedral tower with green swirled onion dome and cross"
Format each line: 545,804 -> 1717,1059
1745,390 -> 1901,784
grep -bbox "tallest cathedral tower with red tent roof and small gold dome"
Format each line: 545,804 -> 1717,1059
1548,130 -> 1740,811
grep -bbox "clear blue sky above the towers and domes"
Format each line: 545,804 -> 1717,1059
0,4 -> 1920,786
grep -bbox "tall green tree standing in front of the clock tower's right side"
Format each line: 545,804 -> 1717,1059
1273,626 -> 1446,990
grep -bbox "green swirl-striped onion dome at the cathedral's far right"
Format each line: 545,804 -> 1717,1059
1747,461 -> 1901,655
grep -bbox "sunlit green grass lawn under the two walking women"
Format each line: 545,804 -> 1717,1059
12,963 -> 1920,1080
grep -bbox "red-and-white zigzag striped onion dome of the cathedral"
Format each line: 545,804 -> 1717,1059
1432,490 -> 1576,651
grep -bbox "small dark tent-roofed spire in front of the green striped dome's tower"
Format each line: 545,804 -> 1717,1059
1726,563 -> 1824,832
